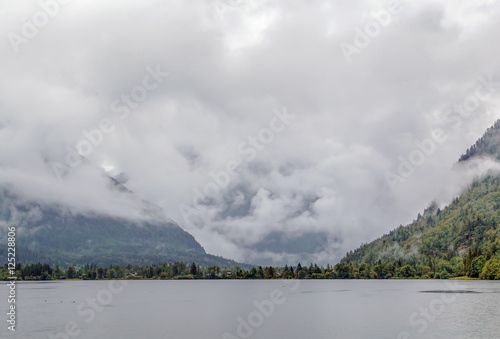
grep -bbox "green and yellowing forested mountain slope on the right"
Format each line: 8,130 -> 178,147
341,120 -> 500,279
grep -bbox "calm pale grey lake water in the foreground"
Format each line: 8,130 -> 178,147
0,280 -> 500,339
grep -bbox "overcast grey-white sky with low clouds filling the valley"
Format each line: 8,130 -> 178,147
0,0 -> 500,264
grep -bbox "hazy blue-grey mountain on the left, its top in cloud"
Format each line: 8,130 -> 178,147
0,163 -> 248,267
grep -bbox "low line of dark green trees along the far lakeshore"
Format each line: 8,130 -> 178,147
0,256 -> 500,281
